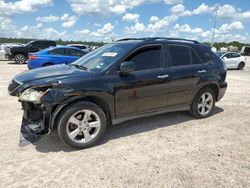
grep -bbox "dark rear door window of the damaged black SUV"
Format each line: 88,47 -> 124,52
169,45 -> 191,67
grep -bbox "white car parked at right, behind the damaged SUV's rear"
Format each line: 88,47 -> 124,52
216,52 -> 246,70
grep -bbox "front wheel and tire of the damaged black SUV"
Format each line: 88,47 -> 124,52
57,101 -> 107,149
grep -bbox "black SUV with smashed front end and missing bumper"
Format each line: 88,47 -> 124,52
8,38 -> 227,148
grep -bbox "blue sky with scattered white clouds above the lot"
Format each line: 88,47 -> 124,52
0,0 -> 250,43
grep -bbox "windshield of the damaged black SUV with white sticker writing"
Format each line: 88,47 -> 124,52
72,43 -> 135,72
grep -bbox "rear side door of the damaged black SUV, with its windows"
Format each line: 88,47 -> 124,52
167,44 -> 206,107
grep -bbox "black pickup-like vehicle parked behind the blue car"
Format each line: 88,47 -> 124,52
5,40 -> 56,64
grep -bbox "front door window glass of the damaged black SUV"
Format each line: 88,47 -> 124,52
126,46 -> 162,70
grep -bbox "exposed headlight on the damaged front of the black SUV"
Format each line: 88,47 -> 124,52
19,88 -> 45,104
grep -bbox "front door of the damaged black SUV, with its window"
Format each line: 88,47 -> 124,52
115,45 -> 168,118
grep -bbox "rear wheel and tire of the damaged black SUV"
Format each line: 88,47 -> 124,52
189,88 -> 215,118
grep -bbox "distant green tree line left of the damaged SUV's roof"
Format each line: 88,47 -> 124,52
0,37 -> 105,46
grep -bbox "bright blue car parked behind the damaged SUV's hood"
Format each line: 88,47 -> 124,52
28,46 -> 87,69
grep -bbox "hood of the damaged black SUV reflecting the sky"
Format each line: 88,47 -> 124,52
14,64 -> 91,84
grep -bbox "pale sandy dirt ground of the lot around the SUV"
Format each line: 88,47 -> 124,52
0,58 -> 250,188
